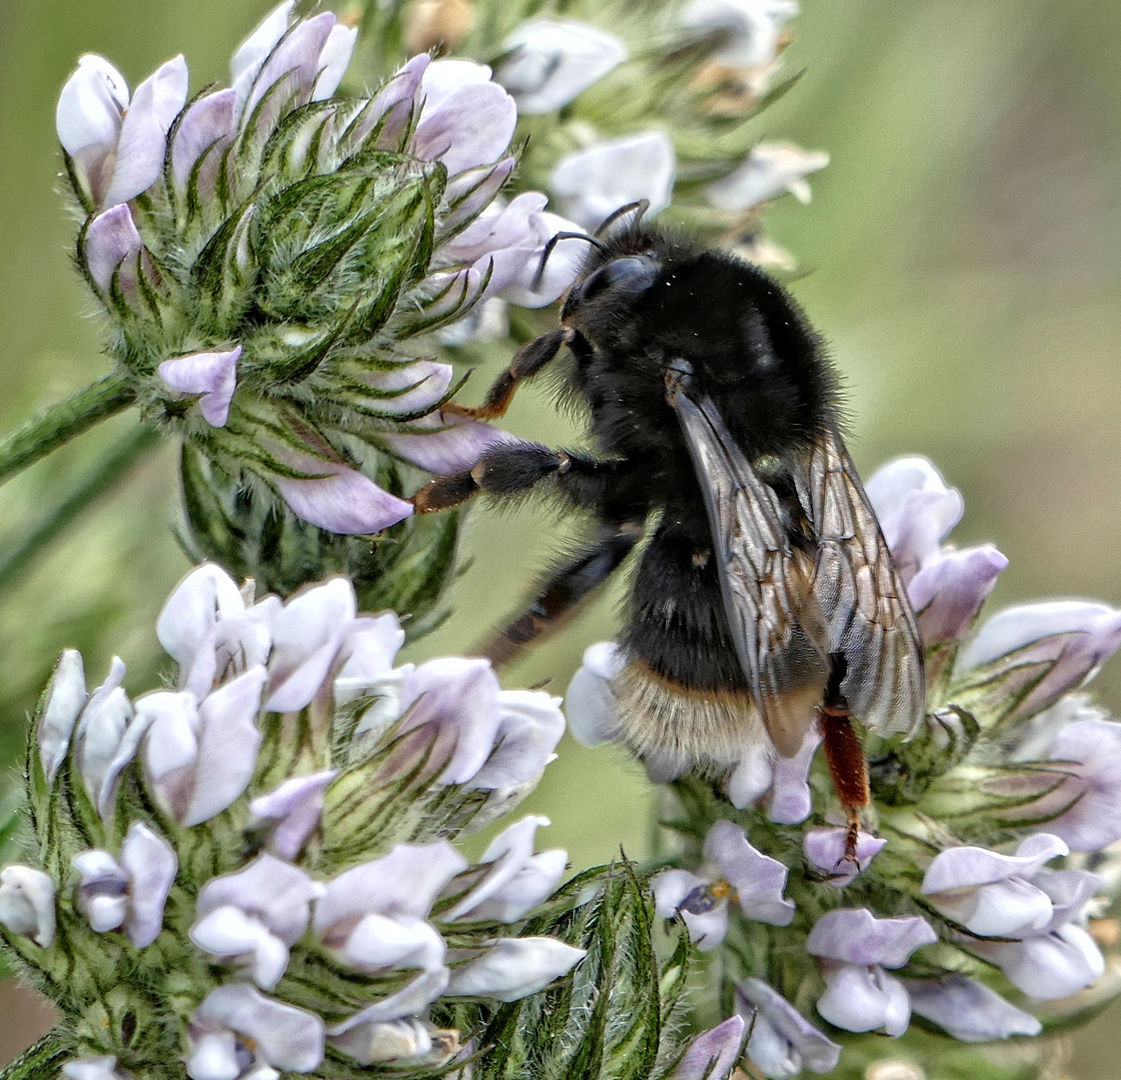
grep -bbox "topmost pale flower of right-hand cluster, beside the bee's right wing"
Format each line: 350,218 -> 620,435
864,458 -> 965,584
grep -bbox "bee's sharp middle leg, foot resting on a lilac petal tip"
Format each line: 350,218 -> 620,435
413,443 -> 615,514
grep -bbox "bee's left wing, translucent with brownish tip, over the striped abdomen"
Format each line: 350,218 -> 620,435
670,394 -> 830,757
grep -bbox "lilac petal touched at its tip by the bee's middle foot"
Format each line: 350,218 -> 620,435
272,451 -> 413,536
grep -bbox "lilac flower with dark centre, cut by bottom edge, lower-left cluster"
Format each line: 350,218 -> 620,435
187,982 -> 324,1080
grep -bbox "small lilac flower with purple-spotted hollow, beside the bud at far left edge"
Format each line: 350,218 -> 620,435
74,821 -> 179,949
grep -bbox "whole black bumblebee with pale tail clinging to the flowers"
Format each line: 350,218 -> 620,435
415,207 -> 926,839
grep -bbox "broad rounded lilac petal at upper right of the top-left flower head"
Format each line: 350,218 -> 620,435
411,82 -> 518,176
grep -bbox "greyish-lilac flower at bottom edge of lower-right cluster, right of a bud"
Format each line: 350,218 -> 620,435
735,979 -> 841,1080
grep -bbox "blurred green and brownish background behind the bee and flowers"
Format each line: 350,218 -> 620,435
0,0 -> 1121,1067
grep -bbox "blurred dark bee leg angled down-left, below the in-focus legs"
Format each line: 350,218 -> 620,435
479,521 -> 642,667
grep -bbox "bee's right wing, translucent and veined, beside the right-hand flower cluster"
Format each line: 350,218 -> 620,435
795,427 -> 926,735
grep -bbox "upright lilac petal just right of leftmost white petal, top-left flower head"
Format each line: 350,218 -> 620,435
102,56 -> 187,206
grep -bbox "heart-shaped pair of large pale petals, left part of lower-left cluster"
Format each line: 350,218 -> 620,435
141,666 -> 266,825
